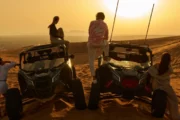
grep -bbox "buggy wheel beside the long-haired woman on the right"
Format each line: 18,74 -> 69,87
151,89 -> 167,118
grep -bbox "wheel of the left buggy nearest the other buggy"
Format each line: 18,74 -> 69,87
72,79 -> 87,110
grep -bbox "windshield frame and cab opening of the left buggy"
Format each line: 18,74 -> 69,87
19,47 -> 67,70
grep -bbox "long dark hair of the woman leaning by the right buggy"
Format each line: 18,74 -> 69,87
158,52 -> 171,75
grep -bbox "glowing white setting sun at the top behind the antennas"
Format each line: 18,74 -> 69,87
104,0 -> 157,18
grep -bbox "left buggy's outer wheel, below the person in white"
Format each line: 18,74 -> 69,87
5,88 -> 23,120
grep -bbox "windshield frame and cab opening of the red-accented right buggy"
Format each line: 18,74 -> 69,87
109,43 -> 153,68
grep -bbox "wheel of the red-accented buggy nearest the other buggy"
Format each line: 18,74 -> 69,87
88,82 -> 100,110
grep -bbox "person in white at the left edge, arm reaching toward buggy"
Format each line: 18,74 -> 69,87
0,58 -> 16,95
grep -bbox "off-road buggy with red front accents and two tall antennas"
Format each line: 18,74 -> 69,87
88,43 -> 166,117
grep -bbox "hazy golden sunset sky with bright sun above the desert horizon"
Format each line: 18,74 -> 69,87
0,0 -> 180,35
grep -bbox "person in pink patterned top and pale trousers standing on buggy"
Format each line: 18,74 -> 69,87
87,12 -> 109,83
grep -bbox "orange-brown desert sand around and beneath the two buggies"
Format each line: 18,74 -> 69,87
0,36 -> 180,120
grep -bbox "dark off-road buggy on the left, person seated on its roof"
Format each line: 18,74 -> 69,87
6,44 -> 86,118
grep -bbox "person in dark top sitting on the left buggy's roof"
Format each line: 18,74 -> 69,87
48,16 -> 69,50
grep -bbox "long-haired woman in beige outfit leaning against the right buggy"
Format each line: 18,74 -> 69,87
148,52 -> 180,120
